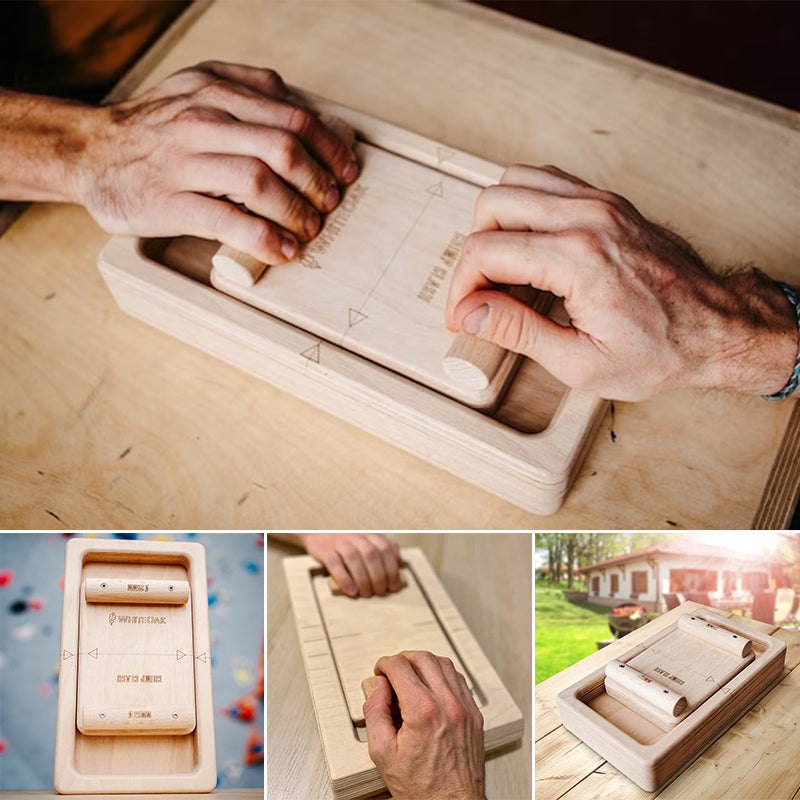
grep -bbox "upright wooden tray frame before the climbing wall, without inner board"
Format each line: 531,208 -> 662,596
54,539 -> 217,794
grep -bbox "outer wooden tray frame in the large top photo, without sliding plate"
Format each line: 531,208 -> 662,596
98,90 -> 608,515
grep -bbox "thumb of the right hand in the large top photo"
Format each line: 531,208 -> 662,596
453,290 -> 577,368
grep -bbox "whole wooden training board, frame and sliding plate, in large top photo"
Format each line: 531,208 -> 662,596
98,87 -> 608,514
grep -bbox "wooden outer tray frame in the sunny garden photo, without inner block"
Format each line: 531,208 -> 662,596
556,607 -> 786,792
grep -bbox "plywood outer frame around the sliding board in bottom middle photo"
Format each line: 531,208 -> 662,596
283,547 -> 524,800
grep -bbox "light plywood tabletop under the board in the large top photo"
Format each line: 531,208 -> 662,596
0,0 -> 800,529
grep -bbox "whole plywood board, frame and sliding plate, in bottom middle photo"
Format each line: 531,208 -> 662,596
284,548 -> 523,800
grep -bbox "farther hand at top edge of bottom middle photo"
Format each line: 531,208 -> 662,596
296,533 -> 402,597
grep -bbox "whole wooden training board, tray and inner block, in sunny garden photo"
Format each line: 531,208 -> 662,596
556,609 -> 786,791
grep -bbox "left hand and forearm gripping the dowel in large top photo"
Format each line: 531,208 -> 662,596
0,61 -> 358,264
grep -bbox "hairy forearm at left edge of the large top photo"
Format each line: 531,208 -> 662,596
0,89 -> 103,202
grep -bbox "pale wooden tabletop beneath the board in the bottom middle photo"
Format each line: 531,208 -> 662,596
267,533 -> 532,800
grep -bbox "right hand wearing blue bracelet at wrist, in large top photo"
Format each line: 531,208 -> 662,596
447,166 -> 797,400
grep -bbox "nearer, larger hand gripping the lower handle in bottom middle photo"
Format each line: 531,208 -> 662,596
364,651 -> 485,800
